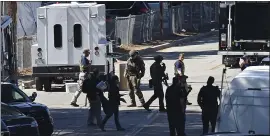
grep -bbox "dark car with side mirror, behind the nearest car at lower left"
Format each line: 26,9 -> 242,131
1,82 -> 53,136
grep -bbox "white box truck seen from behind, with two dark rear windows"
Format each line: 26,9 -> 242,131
31,2 -> 118,91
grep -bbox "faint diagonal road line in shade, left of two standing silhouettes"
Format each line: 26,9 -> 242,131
125,110 -> 159,136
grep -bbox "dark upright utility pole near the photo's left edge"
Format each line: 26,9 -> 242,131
7,1 -> 18,83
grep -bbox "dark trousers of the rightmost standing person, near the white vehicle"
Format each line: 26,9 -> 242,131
202,107 -> 218,134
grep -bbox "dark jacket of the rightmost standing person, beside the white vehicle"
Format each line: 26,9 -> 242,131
197,85 -> 220,108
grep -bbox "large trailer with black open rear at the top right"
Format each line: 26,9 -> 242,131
218,1 -> 270,67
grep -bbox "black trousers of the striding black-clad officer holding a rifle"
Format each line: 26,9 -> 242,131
145,82 -> 164,109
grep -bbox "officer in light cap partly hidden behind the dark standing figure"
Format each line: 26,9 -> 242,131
174,53 -> 192,105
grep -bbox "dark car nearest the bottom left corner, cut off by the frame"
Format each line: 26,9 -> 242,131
1,103 -> 39,136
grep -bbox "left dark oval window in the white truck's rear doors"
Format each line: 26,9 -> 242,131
53,24 -> 62,48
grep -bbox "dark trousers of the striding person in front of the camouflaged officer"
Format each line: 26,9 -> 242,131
102,104 -> 121,128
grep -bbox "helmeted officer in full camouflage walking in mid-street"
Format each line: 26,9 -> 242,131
124,50 -> 145,107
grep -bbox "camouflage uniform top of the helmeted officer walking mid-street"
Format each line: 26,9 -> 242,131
125,56 -> 145,76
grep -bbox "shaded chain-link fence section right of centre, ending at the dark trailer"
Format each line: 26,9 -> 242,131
171,2 -> 219,33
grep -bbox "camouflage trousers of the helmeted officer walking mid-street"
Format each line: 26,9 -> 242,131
127,76 -> 145,104
